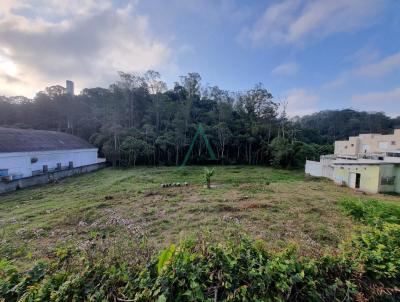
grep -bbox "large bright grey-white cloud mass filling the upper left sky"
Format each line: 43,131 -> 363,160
0,0 -> 174,96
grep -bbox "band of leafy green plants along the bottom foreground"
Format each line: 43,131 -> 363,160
0,229 -> 400,301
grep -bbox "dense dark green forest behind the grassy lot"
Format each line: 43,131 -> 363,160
0,71 -> 400,167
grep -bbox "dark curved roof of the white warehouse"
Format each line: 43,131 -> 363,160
0,127 -> 95,153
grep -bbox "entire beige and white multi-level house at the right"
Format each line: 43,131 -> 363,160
305,129 -> 400,193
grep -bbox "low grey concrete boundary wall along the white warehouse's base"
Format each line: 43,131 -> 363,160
0,163 -> 106,194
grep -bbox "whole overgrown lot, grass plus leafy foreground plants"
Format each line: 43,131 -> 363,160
0,166 -> 400,302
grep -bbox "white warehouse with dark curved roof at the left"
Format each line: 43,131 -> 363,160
0,127 -> 103,179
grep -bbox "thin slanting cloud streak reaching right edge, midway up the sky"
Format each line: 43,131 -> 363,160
325,52 -> 400,88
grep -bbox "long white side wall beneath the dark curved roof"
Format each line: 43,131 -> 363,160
0,148 -> 98,177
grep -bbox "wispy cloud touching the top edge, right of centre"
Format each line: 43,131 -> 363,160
242,0 -> 384,44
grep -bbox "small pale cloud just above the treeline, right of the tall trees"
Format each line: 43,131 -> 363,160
284,89 -> 319,117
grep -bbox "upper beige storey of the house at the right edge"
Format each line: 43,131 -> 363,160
335,129 -> 400,156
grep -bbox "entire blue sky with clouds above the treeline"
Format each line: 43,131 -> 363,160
0,0 -> 400,116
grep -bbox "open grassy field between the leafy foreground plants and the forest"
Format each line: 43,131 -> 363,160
0,166 -> 400,266
